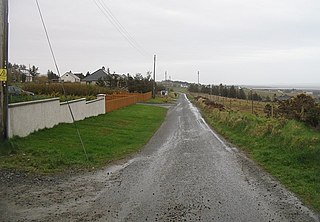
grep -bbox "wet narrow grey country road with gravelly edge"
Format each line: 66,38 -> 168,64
0,95 -> 319,221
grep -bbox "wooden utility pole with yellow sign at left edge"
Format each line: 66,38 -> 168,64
0,0 -> 9,140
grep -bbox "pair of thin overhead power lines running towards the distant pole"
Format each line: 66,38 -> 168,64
93,0 -> 149,57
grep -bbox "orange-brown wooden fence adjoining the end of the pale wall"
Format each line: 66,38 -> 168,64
105,92 -> 152,113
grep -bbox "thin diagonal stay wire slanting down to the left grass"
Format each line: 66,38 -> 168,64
36,0 -> 89,161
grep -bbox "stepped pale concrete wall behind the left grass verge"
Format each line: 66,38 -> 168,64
8,94 -> 106,138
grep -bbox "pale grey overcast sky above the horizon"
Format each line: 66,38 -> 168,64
9,0 -> 320,86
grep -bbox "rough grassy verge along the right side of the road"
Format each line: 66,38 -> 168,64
197,99 -> 320,212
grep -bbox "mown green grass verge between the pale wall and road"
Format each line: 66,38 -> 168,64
0,105 -> 166,173
